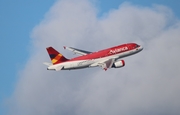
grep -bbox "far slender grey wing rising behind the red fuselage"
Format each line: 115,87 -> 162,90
64,46 -> 92,55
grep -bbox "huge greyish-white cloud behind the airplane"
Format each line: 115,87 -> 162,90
10,0 -> 180,115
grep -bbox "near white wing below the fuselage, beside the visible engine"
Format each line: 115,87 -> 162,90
91,58 -> 115,71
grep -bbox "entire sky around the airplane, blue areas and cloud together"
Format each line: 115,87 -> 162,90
0,0 -> 180,115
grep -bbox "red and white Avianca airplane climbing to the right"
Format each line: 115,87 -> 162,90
44,43 -> 143,71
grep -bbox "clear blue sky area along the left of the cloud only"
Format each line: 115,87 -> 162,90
0,0 -> 55,114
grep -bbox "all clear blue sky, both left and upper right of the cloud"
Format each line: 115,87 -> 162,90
0,0 -> 180,114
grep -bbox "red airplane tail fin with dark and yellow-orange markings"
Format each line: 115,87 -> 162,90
46,47 -> 68,65
